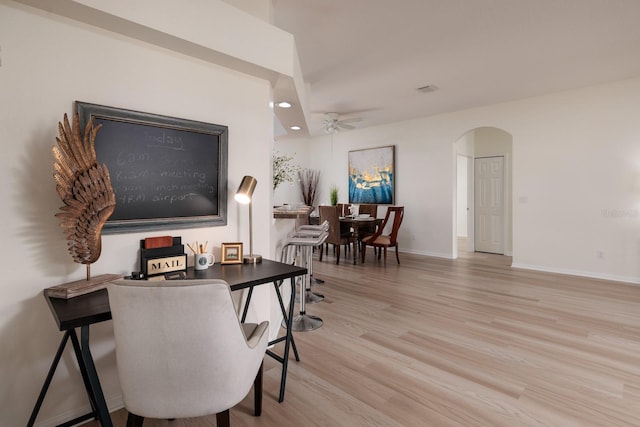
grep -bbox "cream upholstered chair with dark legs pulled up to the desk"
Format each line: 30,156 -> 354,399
107,279 -> 269,427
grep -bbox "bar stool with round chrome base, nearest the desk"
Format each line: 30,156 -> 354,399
282,232 -> 327,332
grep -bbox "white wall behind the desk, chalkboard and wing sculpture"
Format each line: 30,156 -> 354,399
0,0 -> 280,426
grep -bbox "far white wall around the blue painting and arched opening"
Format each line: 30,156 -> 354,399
294,78 -> 640,283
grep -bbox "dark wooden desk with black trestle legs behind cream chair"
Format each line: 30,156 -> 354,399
27,259 -> 307,427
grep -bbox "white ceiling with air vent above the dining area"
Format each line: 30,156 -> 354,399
273,0 -> 640,136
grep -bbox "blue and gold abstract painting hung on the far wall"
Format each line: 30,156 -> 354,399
348,145 -> 396,205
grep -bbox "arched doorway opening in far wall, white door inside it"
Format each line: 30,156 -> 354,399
453,127 -> 513,257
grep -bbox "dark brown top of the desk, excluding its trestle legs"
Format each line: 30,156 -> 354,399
45,259 -> 307,331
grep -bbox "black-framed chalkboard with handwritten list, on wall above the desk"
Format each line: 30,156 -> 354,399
76,101 -> 228,234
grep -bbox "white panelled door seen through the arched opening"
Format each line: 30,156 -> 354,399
474,156 -> 504,254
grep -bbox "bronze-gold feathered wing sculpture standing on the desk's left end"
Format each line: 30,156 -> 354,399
53,113 -> 116,274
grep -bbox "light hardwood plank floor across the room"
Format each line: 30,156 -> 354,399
89,252 -> 640,427
